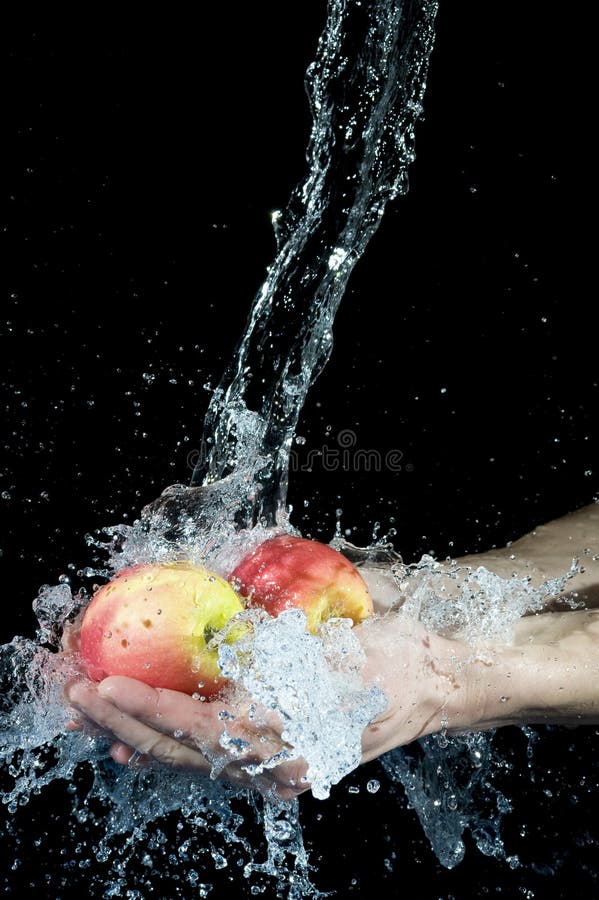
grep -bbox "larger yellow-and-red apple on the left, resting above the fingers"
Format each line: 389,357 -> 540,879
80,562 -> 243,698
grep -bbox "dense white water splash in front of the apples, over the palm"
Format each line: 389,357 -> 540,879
219,609 -> 387,800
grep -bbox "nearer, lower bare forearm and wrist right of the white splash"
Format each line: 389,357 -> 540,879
361,610 -> 599,761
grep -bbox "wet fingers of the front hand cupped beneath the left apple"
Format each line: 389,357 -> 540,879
63,568 -> 408,798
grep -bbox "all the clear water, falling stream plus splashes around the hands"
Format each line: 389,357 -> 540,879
0,0 -> 584,898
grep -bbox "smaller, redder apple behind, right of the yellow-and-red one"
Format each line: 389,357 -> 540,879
229,534 -> 374,633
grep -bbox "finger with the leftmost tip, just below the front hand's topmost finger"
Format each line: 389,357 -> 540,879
68,681 -> 210,772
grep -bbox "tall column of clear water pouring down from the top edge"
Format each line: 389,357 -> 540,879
193,0 -> 437,526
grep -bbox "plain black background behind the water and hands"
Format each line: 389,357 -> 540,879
0,0 -> 598,898
